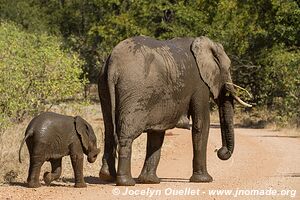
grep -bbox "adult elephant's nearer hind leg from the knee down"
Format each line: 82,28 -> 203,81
116,137 -> 135,186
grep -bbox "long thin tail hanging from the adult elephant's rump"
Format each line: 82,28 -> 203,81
106,56 -> 119,157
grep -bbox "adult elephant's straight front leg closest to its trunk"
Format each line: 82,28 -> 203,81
190,102 -> 213,182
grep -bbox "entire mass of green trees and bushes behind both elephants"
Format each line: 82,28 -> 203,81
0,0 -> 300,129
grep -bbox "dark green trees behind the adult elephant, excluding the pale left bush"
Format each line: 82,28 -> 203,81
0,0 -> 300,125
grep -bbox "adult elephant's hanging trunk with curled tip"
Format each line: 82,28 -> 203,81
218,88 -> 234,160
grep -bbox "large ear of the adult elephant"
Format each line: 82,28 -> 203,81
191,36 -> 231,99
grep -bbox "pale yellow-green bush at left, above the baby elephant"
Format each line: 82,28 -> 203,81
0,22 -> 85,129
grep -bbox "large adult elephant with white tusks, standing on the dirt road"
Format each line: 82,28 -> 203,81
98,36 -> 251,186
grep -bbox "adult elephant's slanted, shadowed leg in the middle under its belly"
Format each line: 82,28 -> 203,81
139,131 -> 165,183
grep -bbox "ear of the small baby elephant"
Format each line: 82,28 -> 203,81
75,116 -> 89,151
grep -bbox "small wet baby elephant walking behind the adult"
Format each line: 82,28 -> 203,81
19,112 -> 100,188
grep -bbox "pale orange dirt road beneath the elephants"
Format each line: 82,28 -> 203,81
0,125 -> 300,200
